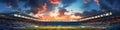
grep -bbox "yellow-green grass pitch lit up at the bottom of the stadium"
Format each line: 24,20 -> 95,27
22,26 -> 102,30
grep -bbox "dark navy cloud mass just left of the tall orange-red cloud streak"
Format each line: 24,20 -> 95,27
22,0 -> 52,13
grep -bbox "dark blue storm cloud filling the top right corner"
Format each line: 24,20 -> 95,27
97,0 -> 120,11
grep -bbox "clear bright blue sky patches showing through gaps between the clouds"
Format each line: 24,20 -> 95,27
0,0 -> 98,13
